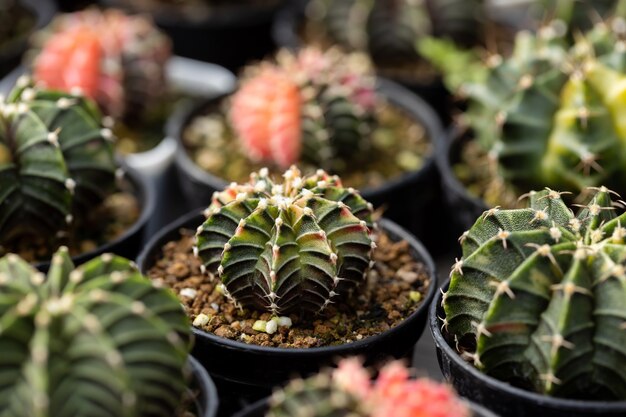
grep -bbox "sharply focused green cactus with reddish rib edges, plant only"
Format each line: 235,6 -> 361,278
195,167 -> 376,314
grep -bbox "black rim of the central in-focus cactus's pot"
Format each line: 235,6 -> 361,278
137,209 -> 437,359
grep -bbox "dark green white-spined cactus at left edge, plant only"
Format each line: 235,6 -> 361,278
0,78 -> 116,243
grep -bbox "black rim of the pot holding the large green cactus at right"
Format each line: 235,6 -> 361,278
428,278 -> 626,413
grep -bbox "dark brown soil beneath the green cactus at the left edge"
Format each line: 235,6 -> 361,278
0,177 -> 141,262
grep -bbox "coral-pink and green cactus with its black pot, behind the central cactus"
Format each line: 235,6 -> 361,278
170,48 -> 441,252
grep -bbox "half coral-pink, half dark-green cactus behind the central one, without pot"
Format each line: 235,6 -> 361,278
229,48 -> 376,172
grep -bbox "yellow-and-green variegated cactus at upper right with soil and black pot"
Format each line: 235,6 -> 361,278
424,19 -> 626,239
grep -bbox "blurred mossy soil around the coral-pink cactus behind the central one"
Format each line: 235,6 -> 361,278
183,98 -> 432,188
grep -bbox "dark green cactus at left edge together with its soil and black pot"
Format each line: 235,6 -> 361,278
0,77 -> 153,269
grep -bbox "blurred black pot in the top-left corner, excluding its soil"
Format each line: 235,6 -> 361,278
0,0 -> 57,77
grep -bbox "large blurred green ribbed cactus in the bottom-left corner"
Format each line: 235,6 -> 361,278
0,248 -> 190,417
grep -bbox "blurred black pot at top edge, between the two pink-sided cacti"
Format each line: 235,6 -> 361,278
99,0 -> 287,71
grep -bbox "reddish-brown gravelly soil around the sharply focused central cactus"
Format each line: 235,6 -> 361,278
148,229 -> 434,348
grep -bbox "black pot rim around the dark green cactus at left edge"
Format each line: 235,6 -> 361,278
31,163 -> 156,270
